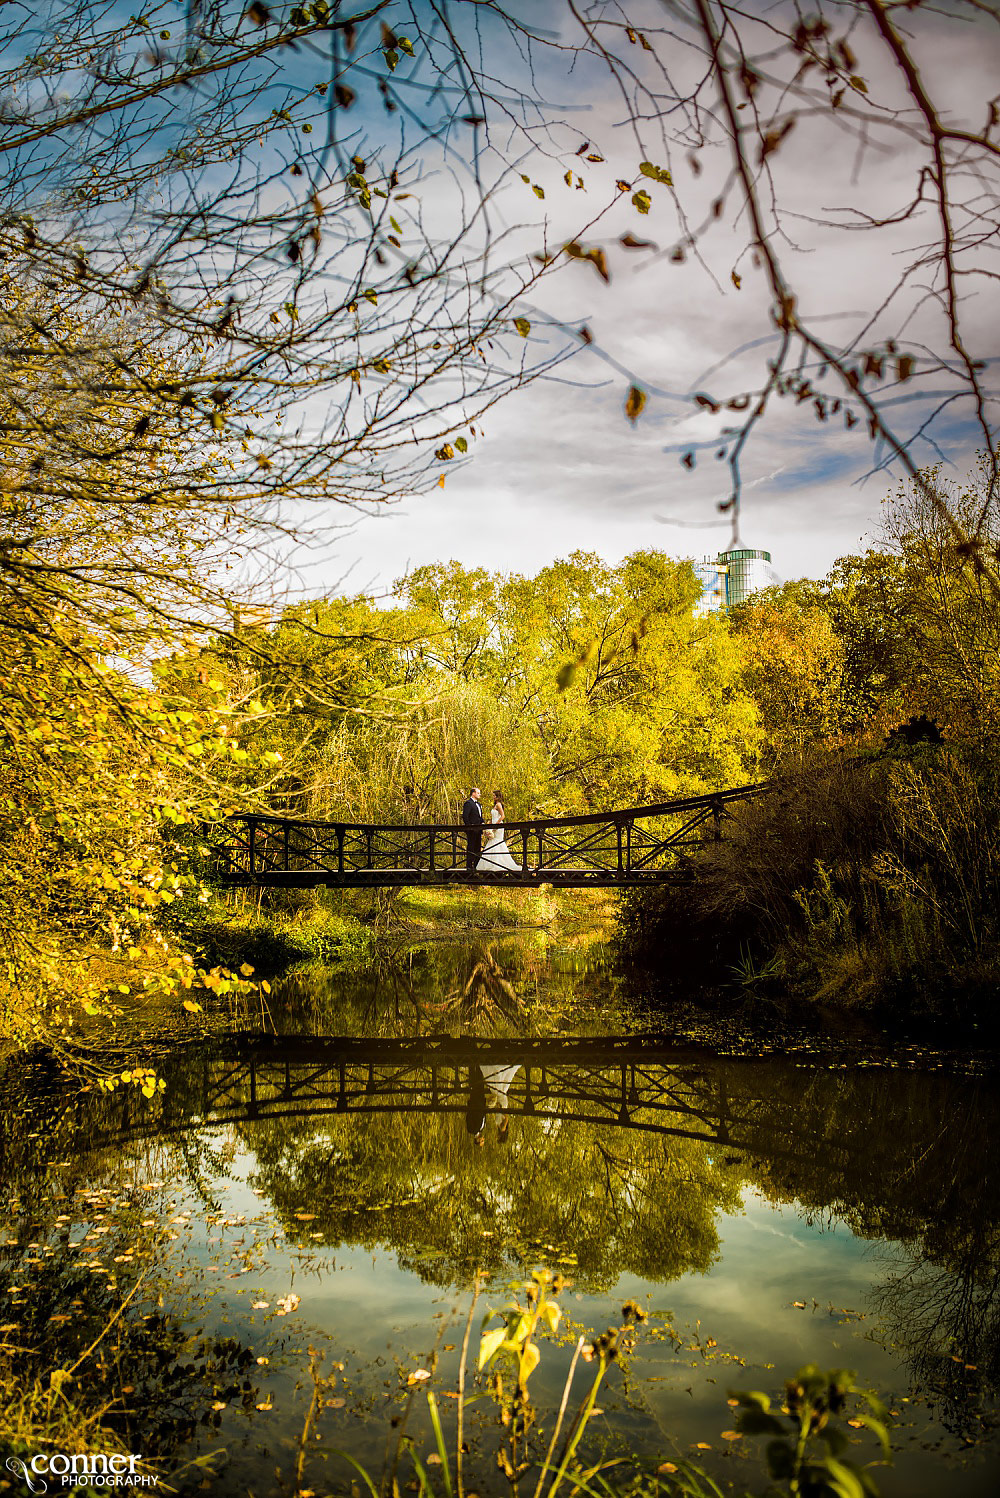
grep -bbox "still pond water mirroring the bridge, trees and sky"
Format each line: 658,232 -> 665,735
0,938 -> 1000,1498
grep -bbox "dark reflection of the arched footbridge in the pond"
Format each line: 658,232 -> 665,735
91,1035 -> 790,1158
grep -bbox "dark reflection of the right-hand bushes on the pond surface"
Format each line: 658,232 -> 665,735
742,1070 -> 1000,1435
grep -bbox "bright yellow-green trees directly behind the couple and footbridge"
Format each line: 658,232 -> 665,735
226,551 -> 759,822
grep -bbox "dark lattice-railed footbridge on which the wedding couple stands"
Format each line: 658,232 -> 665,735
205,782 -> 772,890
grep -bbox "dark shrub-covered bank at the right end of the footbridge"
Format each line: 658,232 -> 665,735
618,742 -> 1000,1044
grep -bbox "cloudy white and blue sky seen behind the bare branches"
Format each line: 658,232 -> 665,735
7,0 -> 1000,608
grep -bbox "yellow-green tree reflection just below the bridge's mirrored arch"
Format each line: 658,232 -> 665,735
241,1113 -> 740,1288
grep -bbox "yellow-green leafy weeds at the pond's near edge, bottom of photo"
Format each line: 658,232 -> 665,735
326,1270 -> 891,1498
